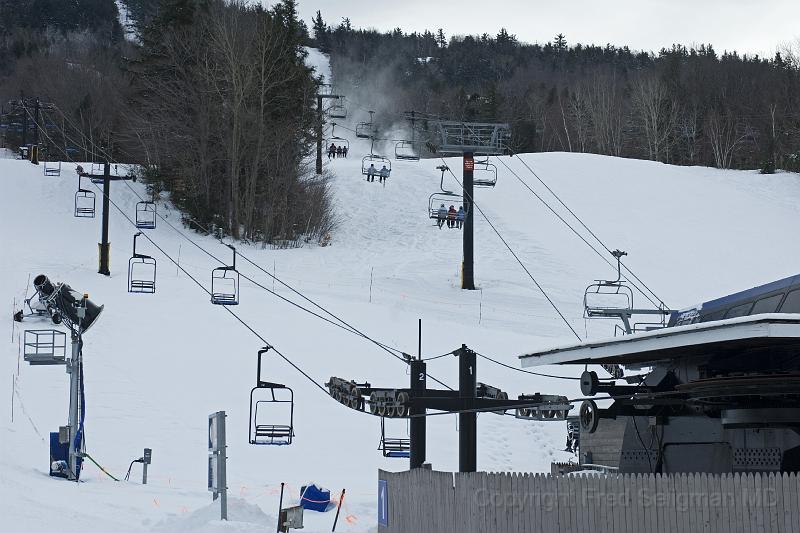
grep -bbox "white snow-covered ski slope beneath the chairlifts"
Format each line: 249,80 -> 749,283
0,84 -> 800,533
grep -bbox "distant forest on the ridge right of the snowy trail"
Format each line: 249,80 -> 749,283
312,12 -> 800,172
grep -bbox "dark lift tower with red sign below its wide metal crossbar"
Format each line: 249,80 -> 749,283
436,121 -> 511,291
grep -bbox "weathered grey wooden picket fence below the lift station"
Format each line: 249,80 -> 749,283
378,469 -> 800,533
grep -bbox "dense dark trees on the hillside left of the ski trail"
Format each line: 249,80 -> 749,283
0,0 -> 333,247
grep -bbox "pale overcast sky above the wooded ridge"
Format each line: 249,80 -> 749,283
288,0 -> 800,56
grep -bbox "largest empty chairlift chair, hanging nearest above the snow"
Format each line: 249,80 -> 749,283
247,347 -> 294,446
